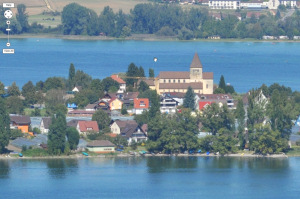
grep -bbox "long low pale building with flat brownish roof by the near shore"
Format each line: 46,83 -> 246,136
86,140 -> 115,153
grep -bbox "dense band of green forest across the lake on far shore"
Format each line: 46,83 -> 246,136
0,3 -> 300,40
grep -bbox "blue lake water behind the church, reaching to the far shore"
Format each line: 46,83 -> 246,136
0,38 -> 300,92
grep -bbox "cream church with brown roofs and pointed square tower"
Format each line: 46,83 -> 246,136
154,53 -> 214,94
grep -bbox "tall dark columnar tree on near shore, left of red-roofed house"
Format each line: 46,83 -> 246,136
47,111 -> 67,155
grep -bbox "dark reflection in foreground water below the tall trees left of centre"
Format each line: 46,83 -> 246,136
46,159 -> 78,178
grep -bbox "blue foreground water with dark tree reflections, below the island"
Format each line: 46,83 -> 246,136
0,157 -> 300,199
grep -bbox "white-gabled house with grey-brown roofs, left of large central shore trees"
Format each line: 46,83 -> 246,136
110,120 -> 148,144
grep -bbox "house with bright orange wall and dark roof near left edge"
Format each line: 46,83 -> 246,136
10,115 -> 31,133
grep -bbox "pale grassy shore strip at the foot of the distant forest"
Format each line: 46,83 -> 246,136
0,33 -> 300,43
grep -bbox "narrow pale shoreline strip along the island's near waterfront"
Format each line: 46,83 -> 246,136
0,153 -> 292,160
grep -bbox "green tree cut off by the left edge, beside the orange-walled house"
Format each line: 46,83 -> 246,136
0,97 -> 10,153
